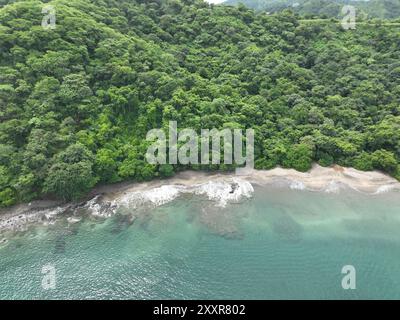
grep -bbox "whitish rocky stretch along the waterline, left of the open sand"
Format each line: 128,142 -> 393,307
0,178 -> 254,231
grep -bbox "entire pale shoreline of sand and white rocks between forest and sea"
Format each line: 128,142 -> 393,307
0,164 -> 400,231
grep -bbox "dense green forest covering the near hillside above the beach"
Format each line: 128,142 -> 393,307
0,0 -> 400,206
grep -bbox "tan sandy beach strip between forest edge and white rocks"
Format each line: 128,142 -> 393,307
96,164 -> 400,199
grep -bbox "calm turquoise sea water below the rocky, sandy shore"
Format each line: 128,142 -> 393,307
0,186 -> 400,299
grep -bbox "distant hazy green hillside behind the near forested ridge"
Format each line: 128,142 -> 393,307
224,0 -> 400,19
